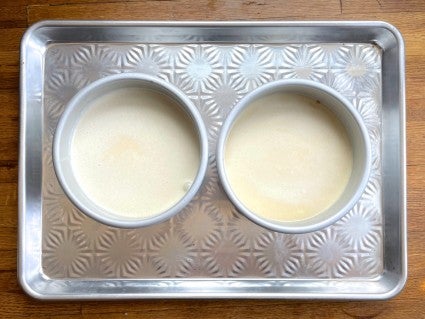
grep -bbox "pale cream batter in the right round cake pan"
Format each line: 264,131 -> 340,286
225,93 -> 353,221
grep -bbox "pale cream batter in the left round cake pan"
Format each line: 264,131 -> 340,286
71,88 -> 200,218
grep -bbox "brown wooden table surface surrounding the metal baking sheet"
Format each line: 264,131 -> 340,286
0,0 -> 425,318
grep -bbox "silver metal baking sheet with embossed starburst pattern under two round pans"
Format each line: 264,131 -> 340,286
19,21 -> 407,299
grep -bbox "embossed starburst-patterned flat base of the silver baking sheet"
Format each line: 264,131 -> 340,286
19,20 -> 403,298
